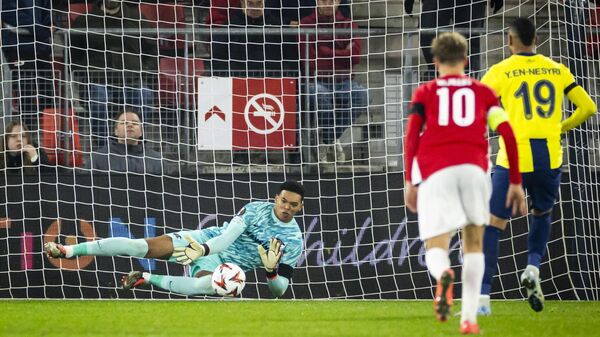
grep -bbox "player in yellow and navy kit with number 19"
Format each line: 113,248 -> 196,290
479,18 -> 596,314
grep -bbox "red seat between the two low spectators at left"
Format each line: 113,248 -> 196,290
40,108 -> 83,167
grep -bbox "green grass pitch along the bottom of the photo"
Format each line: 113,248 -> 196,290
0,300 -> 600,337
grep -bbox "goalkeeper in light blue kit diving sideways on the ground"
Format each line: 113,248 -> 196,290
44,181 -> 304,297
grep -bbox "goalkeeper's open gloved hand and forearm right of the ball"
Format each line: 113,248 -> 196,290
256,238 -> 294,297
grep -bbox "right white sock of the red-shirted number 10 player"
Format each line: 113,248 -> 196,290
460,253 -> 485,323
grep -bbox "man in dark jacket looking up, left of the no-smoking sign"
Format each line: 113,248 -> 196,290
86,109 -> 171,175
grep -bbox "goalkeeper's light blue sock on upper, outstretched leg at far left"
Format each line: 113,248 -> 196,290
70,238 -> 148,257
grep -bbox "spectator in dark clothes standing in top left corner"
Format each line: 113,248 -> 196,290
0,0 -> 55,130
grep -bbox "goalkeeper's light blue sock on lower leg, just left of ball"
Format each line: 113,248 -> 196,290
143,273 -> 215,296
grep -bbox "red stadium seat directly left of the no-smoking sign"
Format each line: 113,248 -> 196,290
159,57 -> 204,106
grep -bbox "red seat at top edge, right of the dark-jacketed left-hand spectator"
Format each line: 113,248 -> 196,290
140,3 -> 191,56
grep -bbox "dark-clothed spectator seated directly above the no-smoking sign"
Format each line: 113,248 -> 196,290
211,0 -> 298,77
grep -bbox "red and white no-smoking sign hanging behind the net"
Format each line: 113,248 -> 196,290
198,77 -> 297,150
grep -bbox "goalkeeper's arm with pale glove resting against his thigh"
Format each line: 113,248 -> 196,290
173,211 -> 247,265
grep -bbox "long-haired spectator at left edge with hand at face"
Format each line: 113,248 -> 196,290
0,121 -> 50,174
